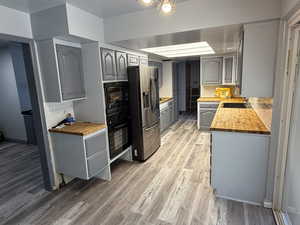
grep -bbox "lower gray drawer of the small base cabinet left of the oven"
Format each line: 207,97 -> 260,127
87,151 -> 108,177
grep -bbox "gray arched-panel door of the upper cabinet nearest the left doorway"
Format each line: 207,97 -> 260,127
56,45 -> 85,101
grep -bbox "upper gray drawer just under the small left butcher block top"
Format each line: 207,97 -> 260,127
85,132 -> 107,158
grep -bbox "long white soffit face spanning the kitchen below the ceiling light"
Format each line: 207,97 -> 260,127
104,0 -> 281,42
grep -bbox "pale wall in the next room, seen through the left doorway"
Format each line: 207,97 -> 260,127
0,48 -> 27,141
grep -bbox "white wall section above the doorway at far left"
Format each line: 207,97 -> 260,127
0,6 -> 32,38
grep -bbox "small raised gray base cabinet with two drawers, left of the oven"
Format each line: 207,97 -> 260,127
51,129 -> 110,180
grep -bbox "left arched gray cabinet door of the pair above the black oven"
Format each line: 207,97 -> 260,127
101,48 -> 116,81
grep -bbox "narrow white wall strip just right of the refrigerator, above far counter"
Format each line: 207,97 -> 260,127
159,61 -> 173,97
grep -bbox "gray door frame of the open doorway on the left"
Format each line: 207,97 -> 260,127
0,34 -> 56,191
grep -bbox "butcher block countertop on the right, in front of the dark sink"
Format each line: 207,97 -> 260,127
210,103 -> 271,134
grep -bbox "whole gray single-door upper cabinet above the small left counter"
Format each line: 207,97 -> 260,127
37,39 -> 86,102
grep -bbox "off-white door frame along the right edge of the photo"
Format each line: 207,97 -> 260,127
273,10 -> 300,218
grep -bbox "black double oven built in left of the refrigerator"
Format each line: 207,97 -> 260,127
104,82 -> 131,159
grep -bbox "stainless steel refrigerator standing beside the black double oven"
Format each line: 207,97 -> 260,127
128,66 -> 160,161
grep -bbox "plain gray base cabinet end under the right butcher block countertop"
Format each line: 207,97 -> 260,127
211,132 -> 270,205
